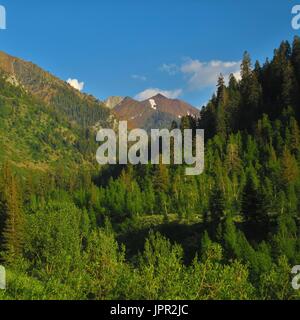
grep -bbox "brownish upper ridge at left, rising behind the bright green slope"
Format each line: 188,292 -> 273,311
0,52 -> 110,127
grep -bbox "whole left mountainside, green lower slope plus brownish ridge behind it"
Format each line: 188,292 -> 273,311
0,52 -> 114,172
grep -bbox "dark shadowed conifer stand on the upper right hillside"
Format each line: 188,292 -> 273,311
201,37 -> 300,137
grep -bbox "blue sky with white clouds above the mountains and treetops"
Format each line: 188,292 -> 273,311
0,0 -> 300,107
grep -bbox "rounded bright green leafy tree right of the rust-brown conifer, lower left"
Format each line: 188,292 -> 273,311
24,200 -> 82,279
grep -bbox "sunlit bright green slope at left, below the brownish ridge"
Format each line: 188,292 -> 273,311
0,72 -> 102,172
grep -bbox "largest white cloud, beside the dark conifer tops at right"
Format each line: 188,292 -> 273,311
180,59 -> 241,90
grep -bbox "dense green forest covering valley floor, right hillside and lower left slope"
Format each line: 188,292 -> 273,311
0,37 -> 300,300
